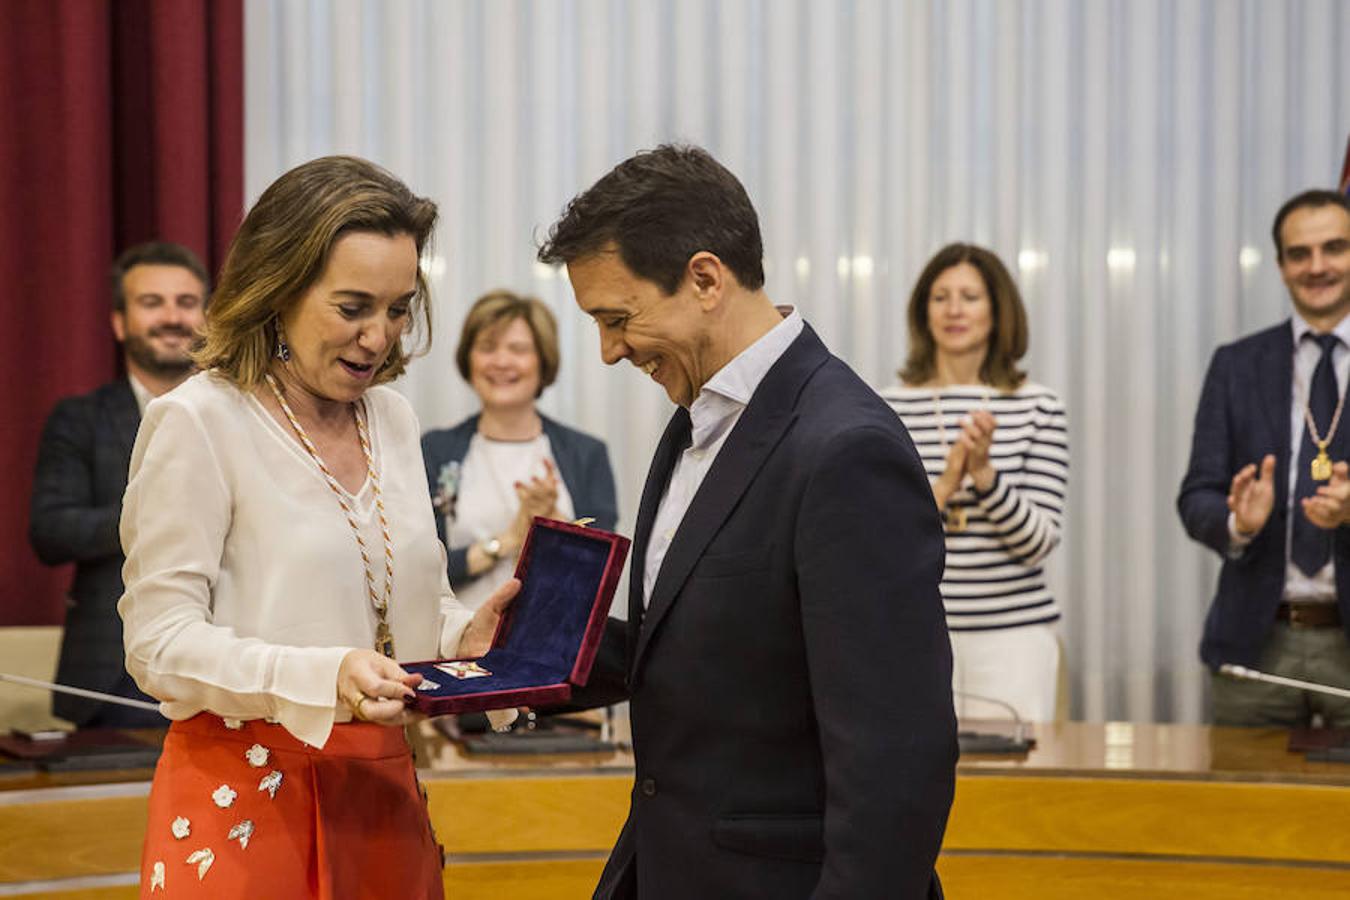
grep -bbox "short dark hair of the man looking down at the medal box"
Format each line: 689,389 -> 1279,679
539,144 -> 764,296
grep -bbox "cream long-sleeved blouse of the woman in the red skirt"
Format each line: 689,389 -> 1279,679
117,372 -> 473,746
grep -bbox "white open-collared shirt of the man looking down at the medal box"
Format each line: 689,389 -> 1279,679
643,306 -> 805,606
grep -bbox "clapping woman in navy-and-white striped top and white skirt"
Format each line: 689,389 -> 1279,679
882,244 -> 1069,722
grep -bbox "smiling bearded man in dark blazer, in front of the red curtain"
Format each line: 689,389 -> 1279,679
28,243 -> 208,727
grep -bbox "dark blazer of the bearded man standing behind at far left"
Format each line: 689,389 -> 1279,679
28,378 -> 165,726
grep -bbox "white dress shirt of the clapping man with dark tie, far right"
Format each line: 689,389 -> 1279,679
1229,313 -> 1350,603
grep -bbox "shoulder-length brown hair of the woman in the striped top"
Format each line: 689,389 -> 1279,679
899,244 -> 1027,390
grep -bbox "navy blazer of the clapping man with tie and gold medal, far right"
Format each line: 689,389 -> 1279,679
1177,320 -> 1350,669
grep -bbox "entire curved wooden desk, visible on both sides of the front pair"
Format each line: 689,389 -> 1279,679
0,723 -> 1350,900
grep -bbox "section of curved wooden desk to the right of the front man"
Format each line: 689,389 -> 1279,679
938,723 -> 1350,900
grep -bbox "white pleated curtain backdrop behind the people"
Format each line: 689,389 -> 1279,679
246,0 -> 1350,722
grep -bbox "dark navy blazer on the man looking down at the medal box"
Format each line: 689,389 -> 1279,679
578,327 -> 957,900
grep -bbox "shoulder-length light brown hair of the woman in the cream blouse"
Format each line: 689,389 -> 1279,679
194,157 -> 436,390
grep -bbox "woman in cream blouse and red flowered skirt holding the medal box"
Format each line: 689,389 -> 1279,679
119,157 -> 518,899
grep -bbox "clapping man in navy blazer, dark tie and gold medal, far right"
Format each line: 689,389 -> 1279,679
1177,190 -> 1350,727
